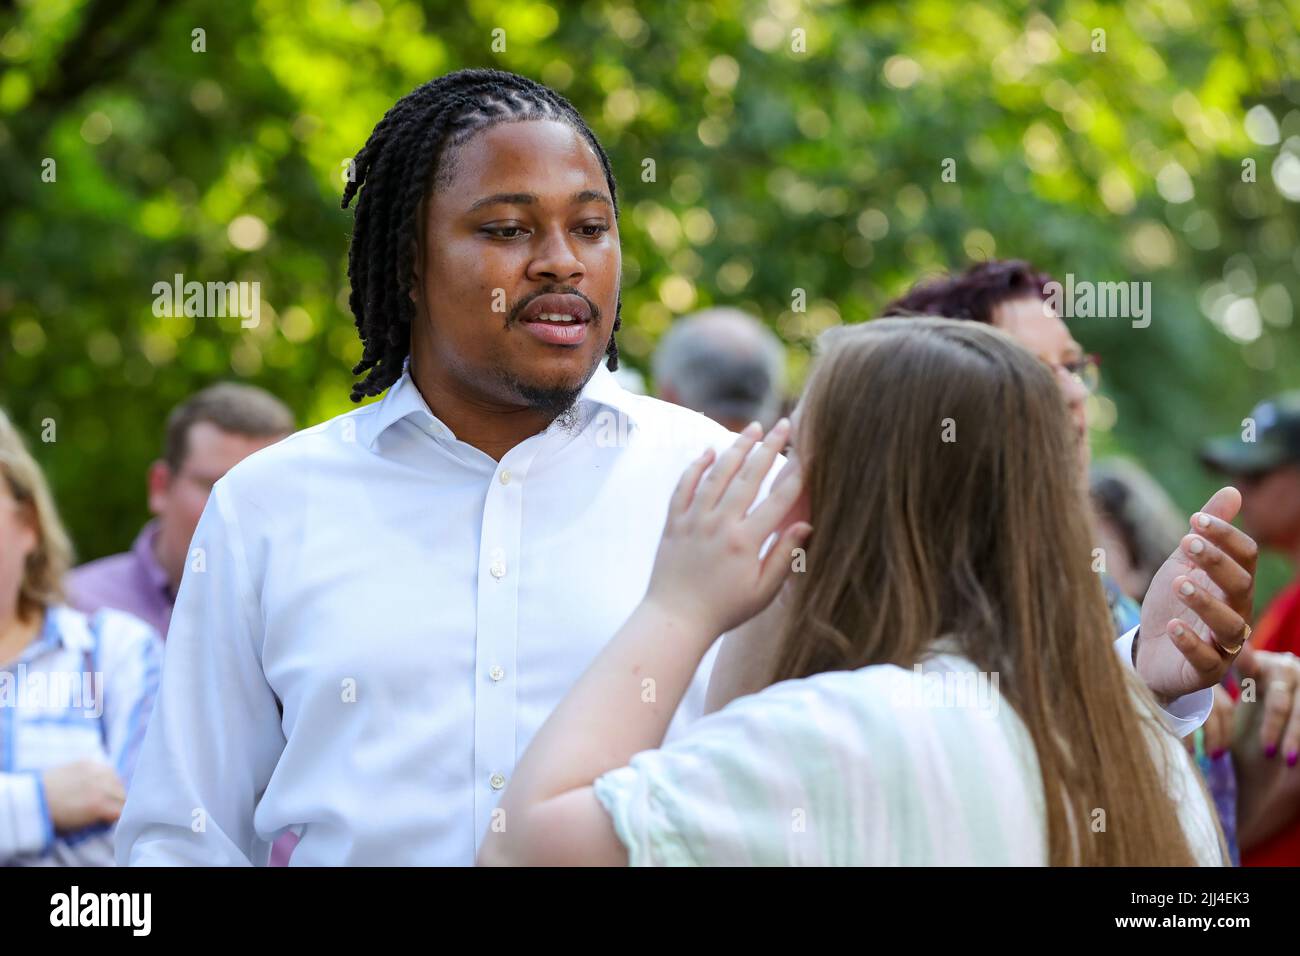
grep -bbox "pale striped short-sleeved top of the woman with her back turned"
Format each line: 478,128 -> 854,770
594,656 -> 1222,866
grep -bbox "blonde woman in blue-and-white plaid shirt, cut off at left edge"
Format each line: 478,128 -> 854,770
0,411 -> 163,866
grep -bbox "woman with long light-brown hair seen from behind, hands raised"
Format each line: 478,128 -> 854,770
480,319 -> 1223,865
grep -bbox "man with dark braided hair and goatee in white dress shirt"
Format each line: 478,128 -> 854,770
117,70 -> 769,865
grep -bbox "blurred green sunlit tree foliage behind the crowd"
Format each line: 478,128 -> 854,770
0,0 -> 1300,593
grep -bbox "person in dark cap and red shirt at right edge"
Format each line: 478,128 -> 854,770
1200,392 -> 1300,866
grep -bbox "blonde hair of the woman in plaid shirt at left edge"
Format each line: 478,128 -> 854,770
0,411 -> 73,617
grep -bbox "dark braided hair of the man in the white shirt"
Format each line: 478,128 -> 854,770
343,69 -> 623,402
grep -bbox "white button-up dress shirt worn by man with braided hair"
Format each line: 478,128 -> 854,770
117,364 -> 1208,865
